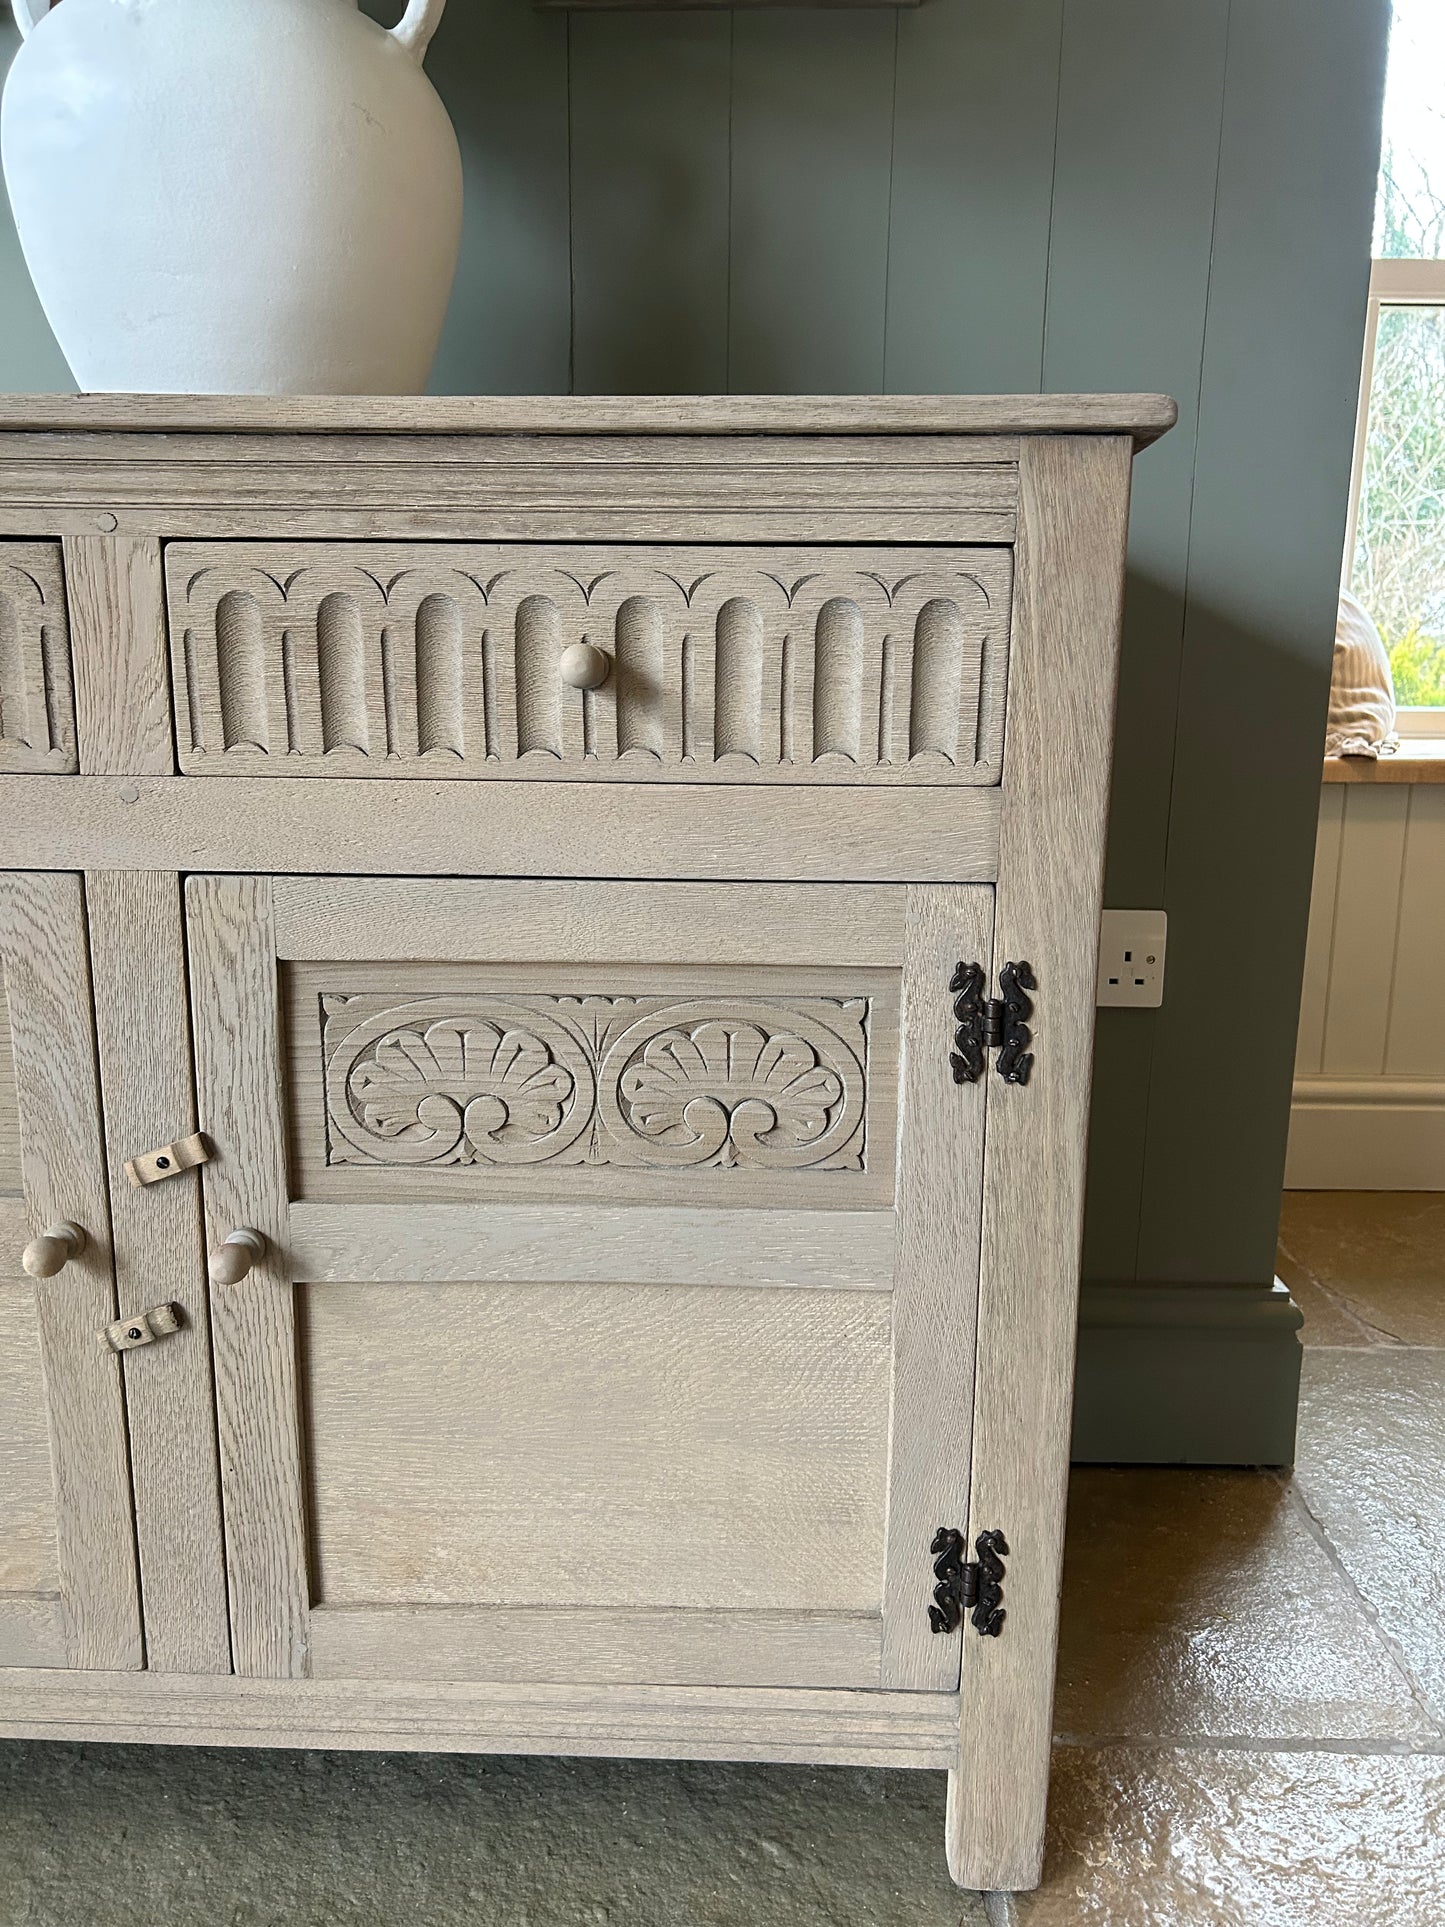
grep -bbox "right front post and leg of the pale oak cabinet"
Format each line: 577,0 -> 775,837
948,439 -> 1129,1888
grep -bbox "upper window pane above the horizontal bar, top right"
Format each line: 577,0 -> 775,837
1376,0 -> 1445,260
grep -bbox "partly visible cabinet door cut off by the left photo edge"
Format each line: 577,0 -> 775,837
0,873 -> 141,1669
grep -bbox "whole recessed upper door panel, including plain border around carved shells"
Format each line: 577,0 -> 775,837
283,959 -> 900,1210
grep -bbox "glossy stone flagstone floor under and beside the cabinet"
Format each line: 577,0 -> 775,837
0,1193 -> 1445,1927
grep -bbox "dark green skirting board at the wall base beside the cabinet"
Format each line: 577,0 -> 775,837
1073,1280 -> 1302,1465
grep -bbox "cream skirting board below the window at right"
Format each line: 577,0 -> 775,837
1285,1077 -> 1445,1191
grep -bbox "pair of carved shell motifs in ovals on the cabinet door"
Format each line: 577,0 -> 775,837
320,992 -> 869,1172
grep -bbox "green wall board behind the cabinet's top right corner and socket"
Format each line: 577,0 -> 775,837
1044,0 -> 1229,1281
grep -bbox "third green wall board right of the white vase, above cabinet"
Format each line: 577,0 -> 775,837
728,10 -> 898,395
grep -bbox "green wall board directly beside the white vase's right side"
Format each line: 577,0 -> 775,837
364,0 -> 568,395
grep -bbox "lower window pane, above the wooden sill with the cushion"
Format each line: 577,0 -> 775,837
1351,306 -> 1445,705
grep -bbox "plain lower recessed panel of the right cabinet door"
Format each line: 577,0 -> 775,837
297,1281 -> 890,1618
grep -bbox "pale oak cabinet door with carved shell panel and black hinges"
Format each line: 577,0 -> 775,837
187,877 -> 992,1690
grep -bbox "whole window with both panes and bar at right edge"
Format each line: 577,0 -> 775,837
1345,0 -> 1445,736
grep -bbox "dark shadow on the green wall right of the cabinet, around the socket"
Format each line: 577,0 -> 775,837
1085,570 -> 1333,1285
